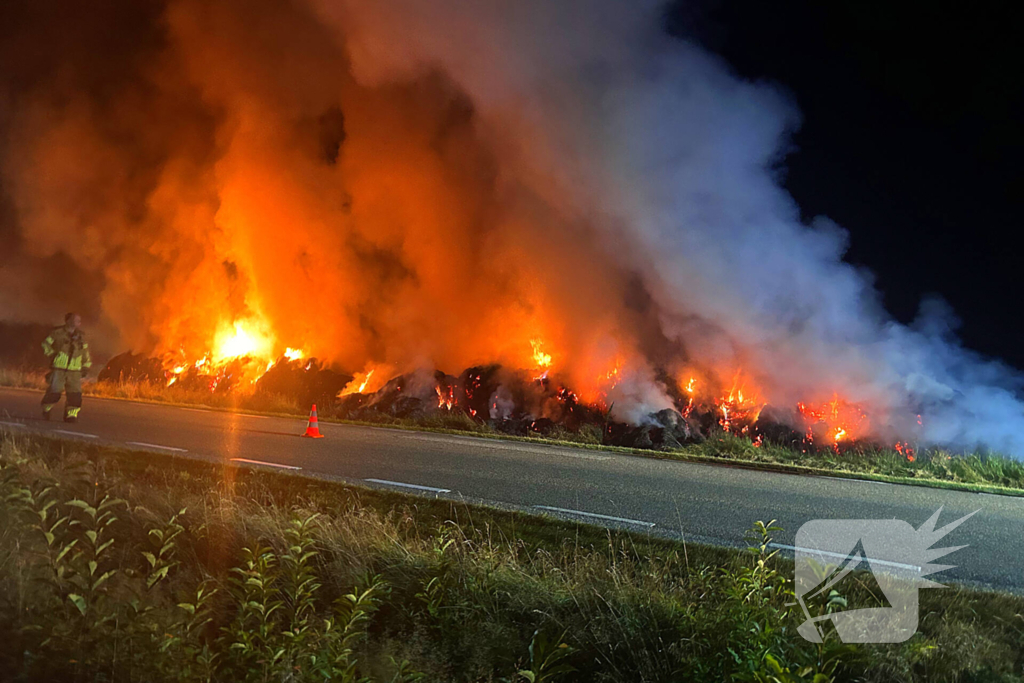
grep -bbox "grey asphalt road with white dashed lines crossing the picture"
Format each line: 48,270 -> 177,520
0,388 -> 1024,593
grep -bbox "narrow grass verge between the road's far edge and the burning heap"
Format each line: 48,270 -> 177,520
6,370 -> 1024,495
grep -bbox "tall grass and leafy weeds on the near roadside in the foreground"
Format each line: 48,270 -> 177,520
0,433 -> 1024,683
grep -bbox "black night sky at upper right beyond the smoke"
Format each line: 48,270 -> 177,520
667,0 -> 1024,369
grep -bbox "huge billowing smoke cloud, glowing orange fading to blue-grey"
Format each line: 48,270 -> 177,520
0,0 -> 1024,454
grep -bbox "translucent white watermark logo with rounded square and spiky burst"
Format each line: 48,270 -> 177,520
793,508 -> 978,643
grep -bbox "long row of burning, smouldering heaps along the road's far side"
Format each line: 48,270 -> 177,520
98,347 -> 920,461
